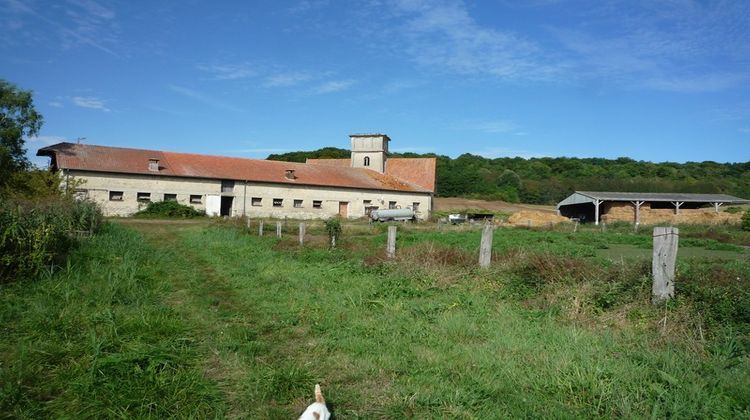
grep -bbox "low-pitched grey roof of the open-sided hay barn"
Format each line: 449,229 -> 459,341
557,191 -> 750,208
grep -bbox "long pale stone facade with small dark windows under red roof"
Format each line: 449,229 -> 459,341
72,170 -> 432,220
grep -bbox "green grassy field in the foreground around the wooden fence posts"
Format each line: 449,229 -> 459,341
0,221 -> 750,418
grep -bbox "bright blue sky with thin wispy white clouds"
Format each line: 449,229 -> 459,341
0,0 -> 750,166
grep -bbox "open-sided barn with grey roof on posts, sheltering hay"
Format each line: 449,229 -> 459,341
557,191 -> 750,225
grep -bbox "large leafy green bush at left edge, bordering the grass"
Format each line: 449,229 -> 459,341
0,197 -> 102,281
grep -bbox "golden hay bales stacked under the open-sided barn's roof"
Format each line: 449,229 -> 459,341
601,203 -> 742,225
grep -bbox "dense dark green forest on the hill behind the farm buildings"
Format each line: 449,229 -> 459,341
268,147 -> 750,204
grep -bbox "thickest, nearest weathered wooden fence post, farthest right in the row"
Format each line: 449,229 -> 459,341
651,227 -> 680,303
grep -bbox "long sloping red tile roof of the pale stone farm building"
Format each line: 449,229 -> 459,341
37,143 -> 434,192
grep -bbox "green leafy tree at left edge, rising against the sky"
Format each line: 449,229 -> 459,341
0,79 -> 42,191
